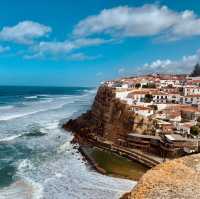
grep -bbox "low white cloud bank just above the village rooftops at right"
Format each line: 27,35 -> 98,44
137,50 -> 200,73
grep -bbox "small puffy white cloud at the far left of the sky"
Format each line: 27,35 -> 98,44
0,21 -> 52,44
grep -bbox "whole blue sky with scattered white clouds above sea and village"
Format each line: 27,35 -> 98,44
0,0 -> 200,86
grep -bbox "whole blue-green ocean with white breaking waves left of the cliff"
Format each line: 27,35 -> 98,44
0,86 -> 135,199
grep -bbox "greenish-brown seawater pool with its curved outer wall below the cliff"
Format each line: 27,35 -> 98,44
72,133 -> 149,181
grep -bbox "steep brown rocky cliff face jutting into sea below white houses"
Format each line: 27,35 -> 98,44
64,86 -> 153,142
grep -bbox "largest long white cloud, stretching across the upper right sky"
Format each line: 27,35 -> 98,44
73,4 -> 200,40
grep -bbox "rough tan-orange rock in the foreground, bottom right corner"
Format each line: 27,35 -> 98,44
124,154 -> 200,199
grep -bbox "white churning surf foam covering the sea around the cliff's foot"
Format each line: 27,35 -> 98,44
0,89 -> 136,199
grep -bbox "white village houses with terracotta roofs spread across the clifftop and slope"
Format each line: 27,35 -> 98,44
104,74 -> 200,158
